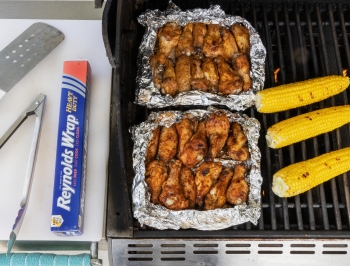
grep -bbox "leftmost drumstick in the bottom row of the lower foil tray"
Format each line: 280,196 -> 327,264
145,160 -> 168,204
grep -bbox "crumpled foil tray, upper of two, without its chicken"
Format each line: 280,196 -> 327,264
136,2 -> 266,111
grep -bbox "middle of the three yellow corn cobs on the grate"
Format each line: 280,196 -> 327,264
266,105 -> 350,149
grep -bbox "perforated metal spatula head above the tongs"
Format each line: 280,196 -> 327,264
0,22 -> 64,99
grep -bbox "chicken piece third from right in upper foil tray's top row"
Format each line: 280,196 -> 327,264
203,24 -> 223,57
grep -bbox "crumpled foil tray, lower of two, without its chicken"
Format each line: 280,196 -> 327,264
130,107 -> 262,230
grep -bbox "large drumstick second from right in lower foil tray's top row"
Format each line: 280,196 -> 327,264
205,113 -> 230,161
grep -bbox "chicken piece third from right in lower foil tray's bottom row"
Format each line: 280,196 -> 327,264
195,162 -> 222,207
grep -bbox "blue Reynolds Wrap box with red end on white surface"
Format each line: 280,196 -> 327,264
51,60 -> 90,236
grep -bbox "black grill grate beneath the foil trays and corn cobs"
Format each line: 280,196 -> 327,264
107,1 -> 350,238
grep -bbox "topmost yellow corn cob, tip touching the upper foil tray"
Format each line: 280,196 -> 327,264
255,76 -> 349,113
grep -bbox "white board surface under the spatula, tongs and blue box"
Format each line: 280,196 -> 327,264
0,19 -> 112,241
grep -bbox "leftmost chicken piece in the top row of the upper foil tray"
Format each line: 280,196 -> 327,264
155,22 -> 182,65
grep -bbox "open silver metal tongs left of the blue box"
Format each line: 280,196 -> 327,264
0,93 -> 46,255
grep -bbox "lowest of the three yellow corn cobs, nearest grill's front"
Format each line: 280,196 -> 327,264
272,145 -> 350,197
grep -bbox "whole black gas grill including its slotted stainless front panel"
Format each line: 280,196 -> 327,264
103,0 -> 350,266
